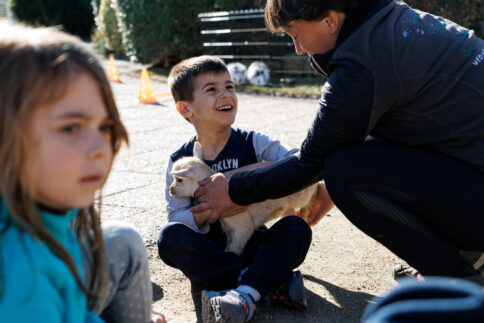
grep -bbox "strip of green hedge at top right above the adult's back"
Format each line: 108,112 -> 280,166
405,0 -> 484,38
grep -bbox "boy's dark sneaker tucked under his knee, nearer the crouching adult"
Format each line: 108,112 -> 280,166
268,270 -> 308,310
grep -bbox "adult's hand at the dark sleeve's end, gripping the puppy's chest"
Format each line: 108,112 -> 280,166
190,173 -> 246,223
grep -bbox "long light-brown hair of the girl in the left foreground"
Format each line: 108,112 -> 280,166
0,20 -> 128,304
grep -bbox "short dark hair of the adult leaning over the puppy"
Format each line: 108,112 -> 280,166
265,0 -> 354,32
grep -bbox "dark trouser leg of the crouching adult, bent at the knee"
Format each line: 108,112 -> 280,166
324,142 -> 484,277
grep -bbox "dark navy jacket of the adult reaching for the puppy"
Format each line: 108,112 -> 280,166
229,0 -> 484,205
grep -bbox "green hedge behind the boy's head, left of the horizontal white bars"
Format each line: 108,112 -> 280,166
116,0 -> 253,67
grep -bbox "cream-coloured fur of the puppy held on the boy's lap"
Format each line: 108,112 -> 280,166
170,142 -> 317,255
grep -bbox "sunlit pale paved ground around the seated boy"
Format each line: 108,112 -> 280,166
102,60 -> 401,322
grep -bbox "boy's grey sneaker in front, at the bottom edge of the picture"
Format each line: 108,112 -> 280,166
202,289 -> 255,323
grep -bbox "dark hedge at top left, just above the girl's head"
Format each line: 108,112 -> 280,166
9,0 -> 94,39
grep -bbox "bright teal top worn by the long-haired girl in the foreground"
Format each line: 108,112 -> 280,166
0,200 -> 103,323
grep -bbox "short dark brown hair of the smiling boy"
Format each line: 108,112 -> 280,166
168,55 -> 228,102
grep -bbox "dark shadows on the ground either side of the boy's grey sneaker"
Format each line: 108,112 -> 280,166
187,275 -> 374,323
